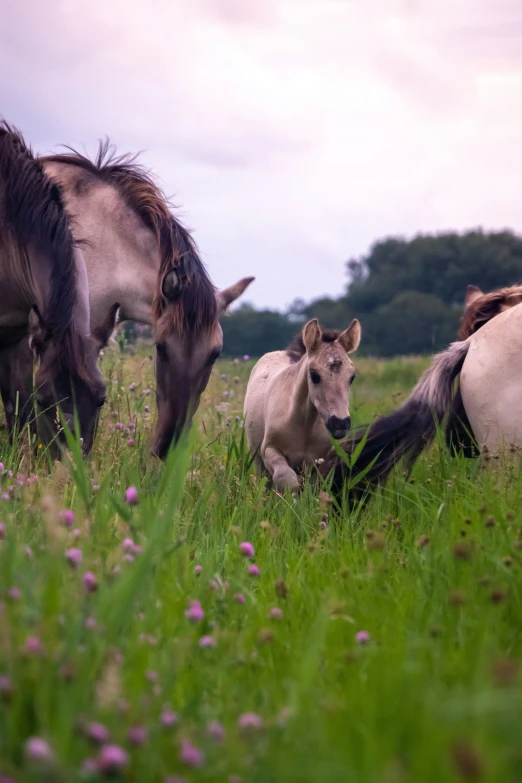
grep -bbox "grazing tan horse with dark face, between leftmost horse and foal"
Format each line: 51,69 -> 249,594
37,142 -> 254,458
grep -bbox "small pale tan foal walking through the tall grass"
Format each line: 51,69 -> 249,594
244,318 -> 361,490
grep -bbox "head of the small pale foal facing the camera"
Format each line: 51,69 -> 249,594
302,318 -> 361,440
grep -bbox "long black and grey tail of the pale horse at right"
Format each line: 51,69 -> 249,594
322,340 -> 469,493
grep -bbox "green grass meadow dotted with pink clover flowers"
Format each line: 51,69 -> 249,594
0,351 -> 522,783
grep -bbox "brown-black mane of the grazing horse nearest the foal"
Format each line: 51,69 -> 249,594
41,138 -> 218,333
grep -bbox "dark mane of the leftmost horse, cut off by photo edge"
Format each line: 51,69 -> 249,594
0,120 -> 87,380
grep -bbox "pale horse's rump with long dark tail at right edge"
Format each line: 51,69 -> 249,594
321,304 -> 522,496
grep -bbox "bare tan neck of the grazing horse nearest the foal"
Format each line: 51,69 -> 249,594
45,161 -> 160,329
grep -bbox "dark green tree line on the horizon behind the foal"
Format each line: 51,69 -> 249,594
221,230 -> 522,356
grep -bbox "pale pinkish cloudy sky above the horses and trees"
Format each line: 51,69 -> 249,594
0,0 -> 522,307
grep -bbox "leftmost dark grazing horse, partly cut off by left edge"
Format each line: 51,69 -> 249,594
0,122 -> 105,453
